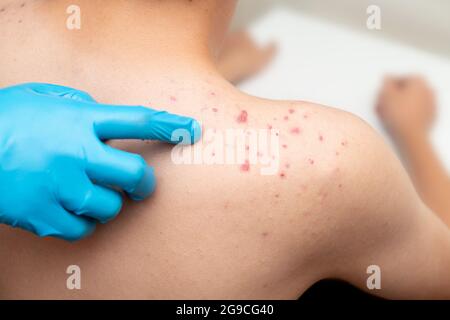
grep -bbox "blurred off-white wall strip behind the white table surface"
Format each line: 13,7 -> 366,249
234,0 -> 450,57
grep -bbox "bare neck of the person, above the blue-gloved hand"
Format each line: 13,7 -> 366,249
36,0 -> 235,79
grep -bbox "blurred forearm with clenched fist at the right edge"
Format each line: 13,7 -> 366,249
377,77 -> 450,225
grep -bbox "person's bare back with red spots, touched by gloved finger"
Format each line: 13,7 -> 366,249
0,1 -> 450,299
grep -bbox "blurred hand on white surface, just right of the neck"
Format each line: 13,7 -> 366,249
217,31 -> 276,84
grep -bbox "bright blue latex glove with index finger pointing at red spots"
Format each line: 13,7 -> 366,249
0,83 -> 201,241
